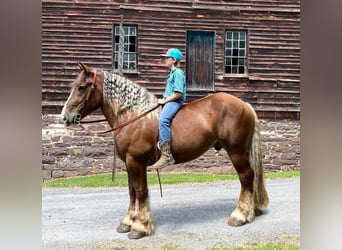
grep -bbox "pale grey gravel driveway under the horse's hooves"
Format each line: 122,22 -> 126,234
42,177 -> 300,250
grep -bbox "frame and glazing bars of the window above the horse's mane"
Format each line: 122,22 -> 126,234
112,23 -> 138,74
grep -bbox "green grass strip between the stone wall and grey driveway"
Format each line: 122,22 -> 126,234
43,171 -> 300,188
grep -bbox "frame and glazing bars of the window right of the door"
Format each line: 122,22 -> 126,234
223,28 -> 249,77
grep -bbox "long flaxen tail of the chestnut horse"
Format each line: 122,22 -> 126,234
248,105 -> 269,211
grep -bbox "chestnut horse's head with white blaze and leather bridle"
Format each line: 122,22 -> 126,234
61,62 -> 102,126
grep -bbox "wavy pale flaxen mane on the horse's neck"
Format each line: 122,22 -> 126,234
103,71 -> 157,117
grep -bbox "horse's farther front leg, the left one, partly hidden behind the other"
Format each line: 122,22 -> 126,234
116,169 -> 136,233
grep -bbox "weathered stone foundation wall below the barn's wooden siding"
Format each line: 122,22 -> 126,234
42,115 -> 300,181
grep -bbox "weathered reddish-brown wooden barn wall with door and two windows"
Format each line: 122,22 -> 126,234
42,0 -> 300,119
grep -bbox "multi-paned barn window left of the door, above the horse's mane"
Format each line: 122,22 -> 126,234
113,24 -> 137,72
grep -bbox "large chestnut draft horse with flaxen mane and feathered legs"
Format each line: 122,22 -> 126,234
61,63 -> 269,239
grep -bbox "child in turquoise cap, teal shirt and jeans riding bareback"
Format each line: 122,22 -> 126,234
149,48 -> 186,169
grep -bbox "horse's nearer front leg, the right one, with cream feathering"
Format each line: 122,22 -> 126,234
126,155 -> 154,239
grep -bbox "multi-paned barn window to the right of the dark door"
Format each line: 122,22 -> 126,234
224,31 -> 247,76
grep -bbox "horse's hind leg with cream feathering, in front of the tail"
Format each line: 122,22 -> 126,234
228,153 -> 255,226
